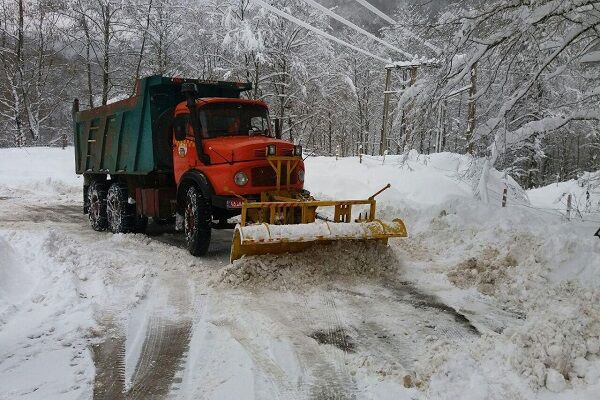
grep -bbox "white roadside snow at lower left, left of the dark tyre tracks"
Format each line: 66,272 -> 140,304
0,224 -> 157,399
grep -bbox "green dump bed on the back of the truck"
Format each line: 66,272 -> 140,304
73,75 -> 251,175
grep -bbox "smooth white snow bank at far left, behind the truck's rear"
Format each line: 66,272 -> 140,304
0,147 -> 81,196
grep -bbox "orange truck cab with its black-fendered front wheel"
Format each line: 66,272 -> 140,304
173,85 -> 304,255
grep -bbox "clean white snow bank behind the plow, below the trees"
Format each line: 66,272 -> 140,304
305,151 -> 527,209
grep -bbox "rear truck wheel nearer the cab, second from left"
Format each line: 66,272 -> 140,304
106,182 -> 137,233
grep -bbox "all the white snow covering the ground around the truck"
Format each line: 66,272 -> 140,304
0,148 -> 600,400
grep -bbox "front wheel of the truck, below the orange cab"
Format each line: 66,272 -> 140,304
184,186 -> 212,256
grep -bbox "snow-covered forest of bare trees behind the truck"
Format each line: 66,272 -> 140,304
0,0 -> 600,188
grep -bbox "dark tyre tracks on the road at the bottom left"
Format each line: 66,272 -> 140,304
94,272 -> 193,400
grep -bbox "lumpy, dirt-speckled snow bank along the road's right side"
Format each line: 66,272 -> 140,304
398,201 -> 600,399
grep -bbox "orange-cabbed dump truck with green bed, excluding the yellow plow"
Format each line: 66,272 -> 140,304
73,76 -> 304,255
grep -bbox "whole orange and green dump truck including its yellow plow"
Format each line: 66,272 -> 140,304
73,75 -> 407,262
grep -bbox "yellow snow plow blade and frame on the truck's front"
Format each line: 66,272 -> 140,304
230,185 -> 407,262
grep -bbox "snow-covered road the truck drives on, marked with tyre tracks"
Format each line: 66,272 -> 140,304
0,192 -> 477,399
